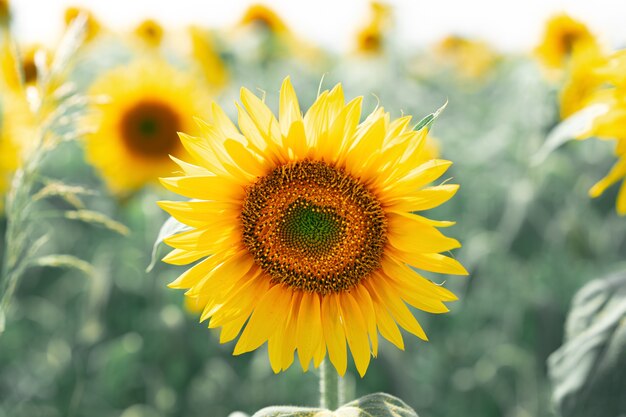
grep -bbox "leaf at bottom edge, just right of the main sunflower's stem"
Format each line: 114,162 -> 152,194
333,392 -> 418,417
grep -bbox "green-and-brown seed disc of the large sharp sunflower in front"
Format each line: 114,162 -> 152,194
241,161 -> 387,294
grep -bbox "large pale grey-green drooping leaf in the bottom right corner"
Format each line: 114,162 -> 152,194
548,272 -> 626,417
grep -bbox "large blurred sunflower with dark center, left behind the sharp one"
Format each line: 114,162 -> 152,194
87,59 -> 210,194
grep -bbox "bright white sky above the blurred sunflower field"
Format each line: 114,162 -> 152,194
10,0 -> 626,50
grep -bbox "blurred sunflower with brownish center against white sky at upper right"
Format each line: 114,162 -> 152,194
535,14 -> 598,70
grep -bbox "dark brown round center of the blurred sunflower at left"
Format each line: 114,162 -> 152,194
120,101 -> 182,158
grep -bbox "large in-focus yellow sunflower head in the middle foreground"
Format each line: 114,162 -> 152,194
159,78 -> 467,375
